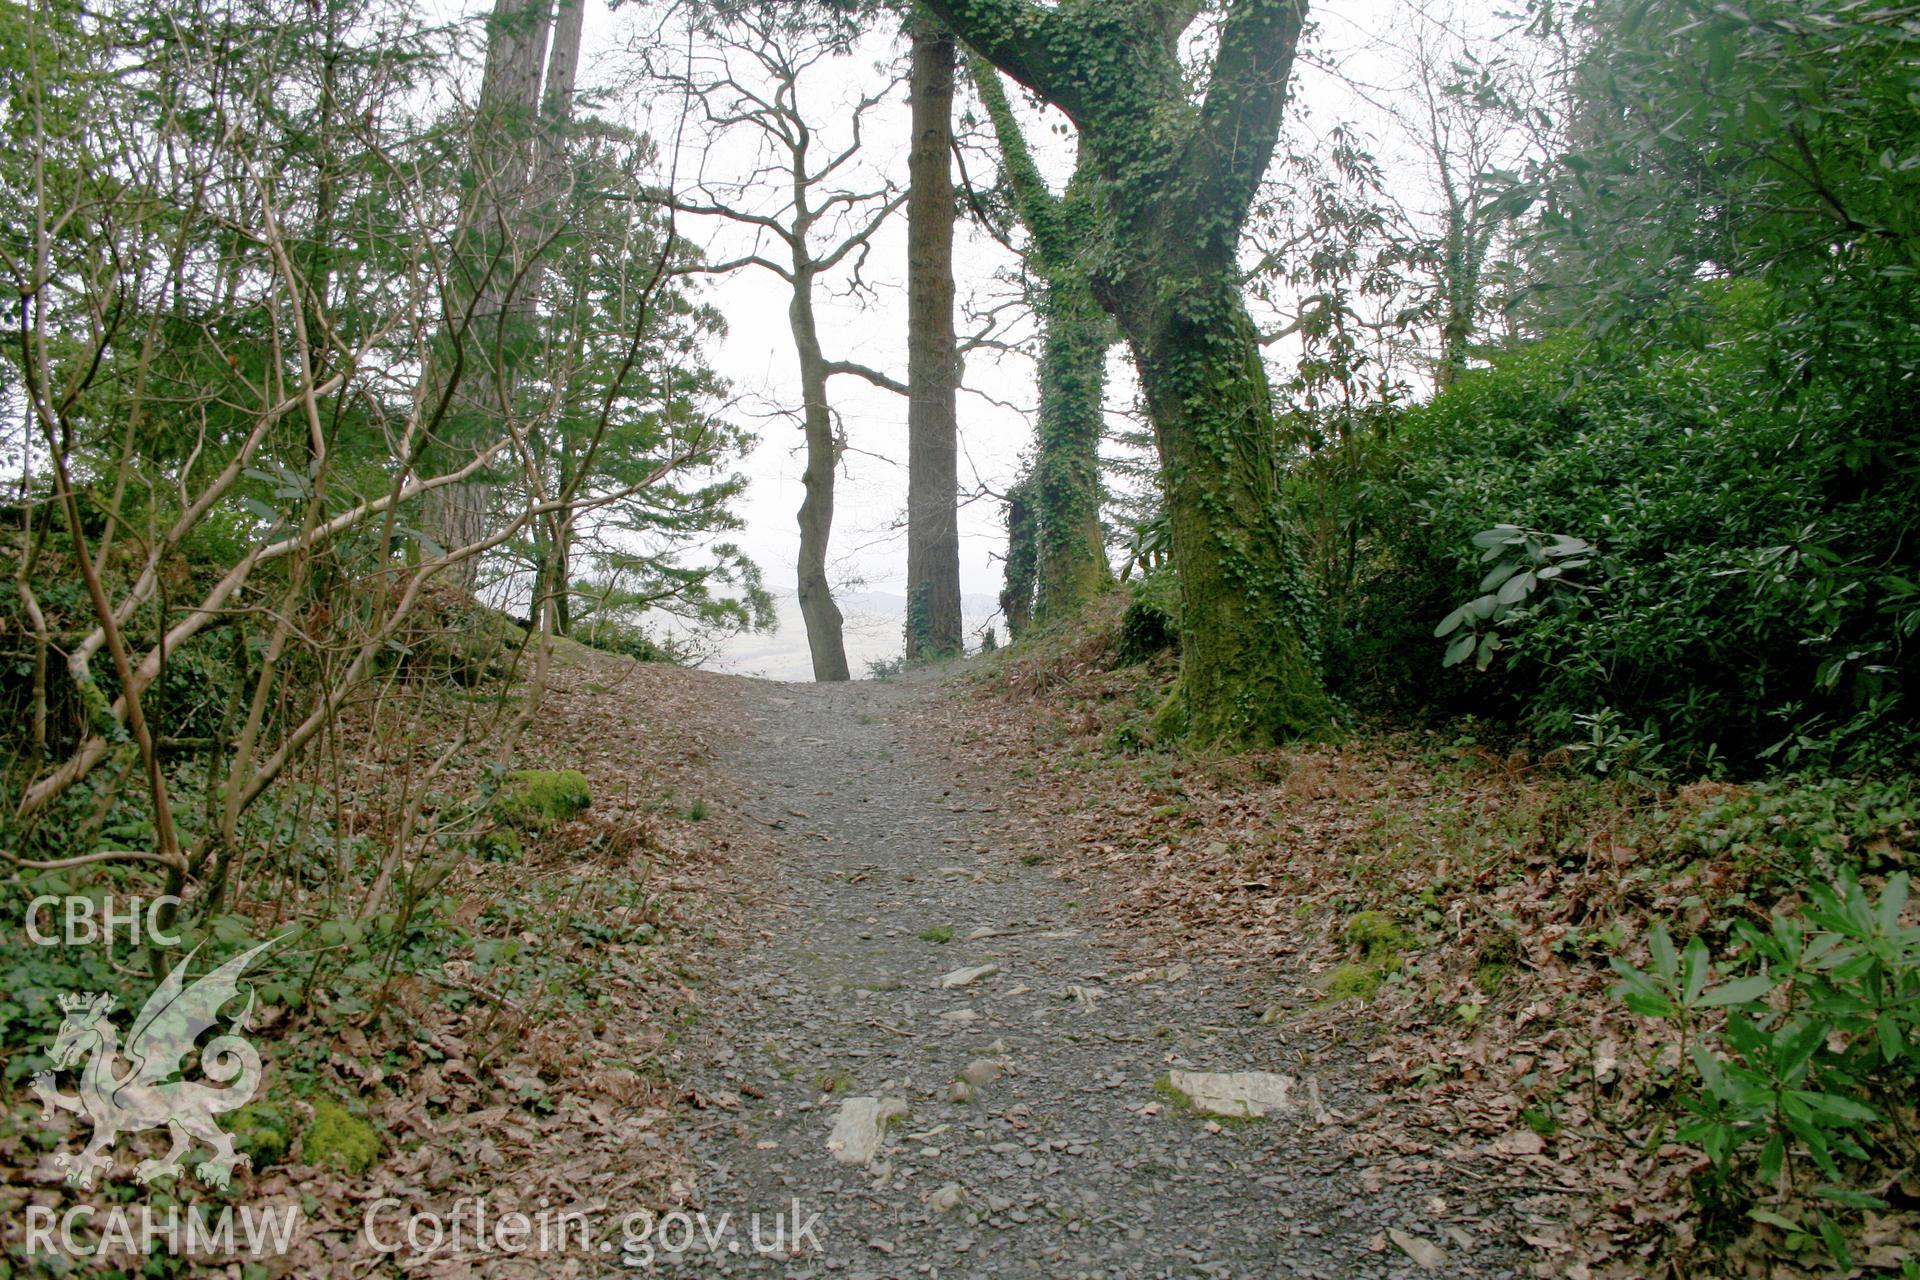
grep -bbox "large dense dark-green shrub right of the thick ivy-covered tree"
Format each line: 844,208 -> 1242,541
1294,284 -> 1920,771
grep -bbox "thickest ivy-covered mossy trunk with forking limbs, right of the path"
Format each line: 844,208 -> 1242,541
925,0 -> 1331,747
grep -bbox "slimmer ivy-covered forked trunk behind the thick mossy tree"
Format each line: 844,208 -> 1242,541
972,58 -> 1114,637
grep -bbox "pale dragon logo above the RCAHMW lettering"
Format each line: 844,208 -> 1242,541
33,938 -> 278,1188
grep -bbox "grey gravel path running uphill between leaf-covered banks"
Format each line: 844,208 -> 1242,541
672,681 -> 1517,1280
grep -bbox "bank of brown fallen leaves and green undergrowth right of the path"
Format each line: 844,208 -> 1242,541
962,597 -> 1920,1276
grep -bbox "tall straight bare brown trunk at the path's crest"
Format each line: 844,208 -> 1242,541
906,15 -> 964,660
